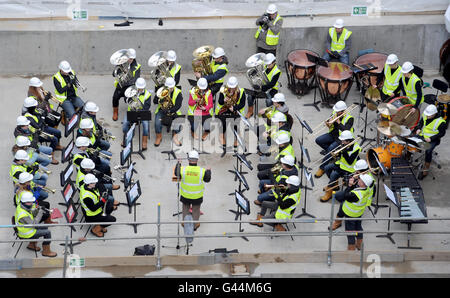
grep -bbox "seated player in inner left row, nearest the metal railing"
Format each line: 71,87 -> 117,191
80,174 -> 117,237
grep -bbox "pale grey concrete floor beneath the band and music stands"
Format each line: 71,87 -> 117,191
0,66 -> 450,273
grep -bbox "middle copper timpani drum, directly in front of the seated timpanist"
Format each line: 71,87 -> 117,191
316,62 -> 353,106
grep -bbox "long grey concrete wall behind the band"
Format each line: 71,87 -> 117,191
0,24 -> 449,75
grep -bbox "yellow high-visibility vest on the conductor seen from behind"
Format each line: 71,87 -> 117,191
180,166 -> 205,200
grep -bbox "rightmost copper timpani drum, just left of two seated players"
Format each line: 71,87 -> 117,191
354,52 -> 387,92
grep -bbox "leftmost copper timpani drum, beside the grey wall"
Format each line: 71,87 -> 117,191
285,50 -> 319,95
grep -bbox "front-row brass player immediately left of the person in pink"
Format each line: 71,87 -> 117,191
153,77 -> 183,147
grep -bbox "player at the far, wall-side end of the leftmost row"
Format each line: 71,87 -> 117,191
26,77 -> 61,128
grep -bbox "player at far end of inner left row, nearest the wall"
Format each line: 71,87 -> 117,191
53,61 -> 84,119
